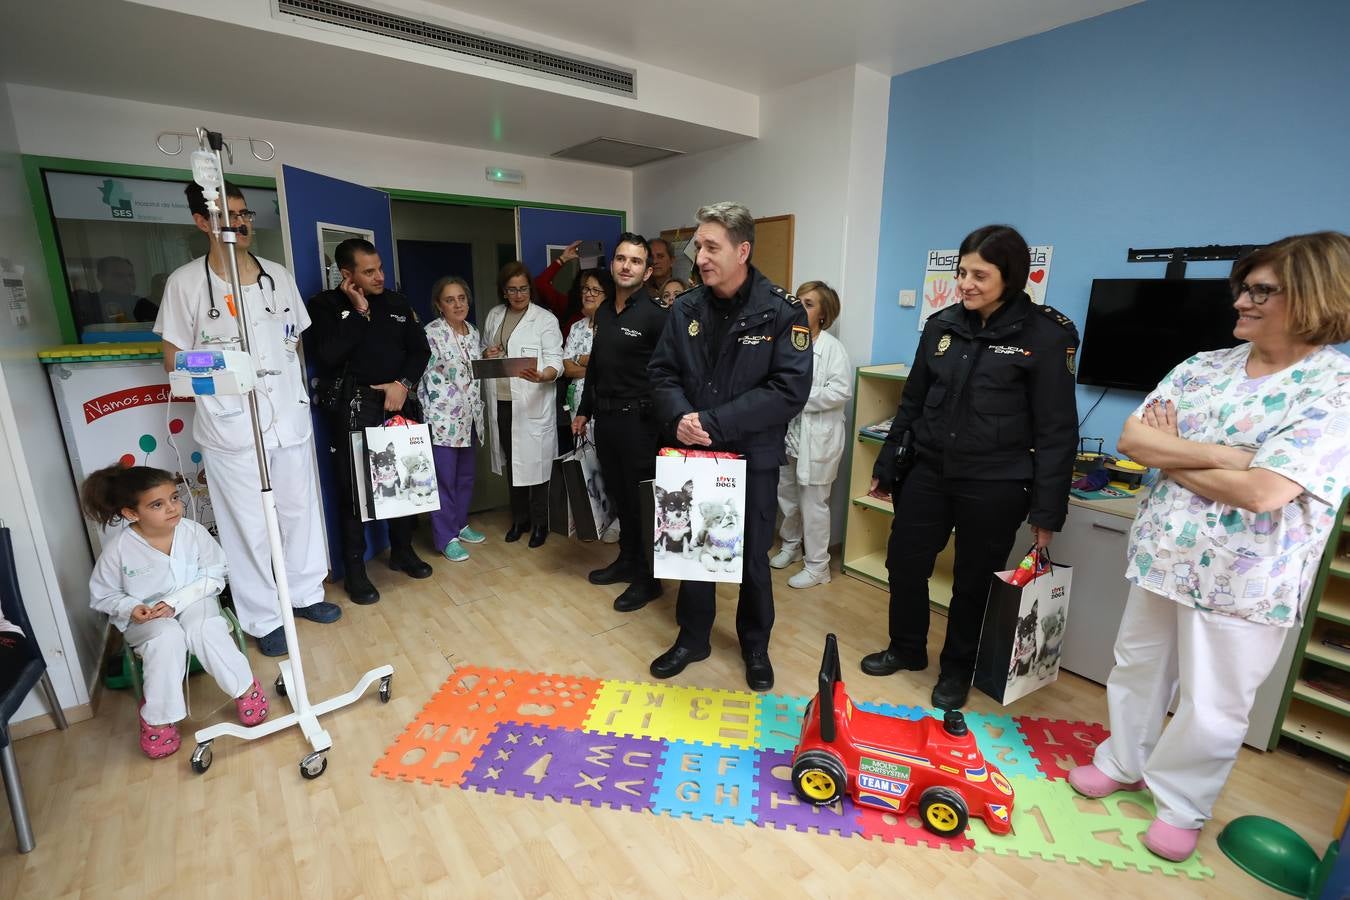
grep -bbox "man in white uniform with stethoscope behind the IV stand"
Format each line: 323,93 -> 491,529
154,184 -> 342,656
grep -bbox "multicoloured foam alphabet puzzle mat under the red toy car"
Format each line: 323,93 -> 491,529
373,667 -> 1214,878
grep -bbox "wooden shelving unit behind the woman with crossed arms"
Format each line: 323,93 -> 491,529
1270,496 -> 1350,762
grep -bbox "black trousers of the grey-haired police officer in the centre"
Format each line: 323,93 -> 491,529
675,468 -> 778,654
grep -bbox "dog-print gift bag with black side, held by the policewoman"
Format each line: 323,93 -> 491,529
975,557 -> 1073,706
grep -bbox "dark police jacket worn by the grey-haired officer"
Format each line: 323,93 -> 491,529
647,266 -> 811,468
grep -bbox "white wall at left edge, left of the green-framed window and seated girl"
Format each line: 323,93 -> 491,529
0,79 -> 104,722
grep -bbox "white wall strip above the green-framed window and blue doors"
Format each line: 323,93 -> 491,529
8,84 -> 633,217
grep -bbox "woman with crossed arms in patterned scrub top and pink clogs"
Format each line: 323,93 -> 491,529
1069,232 -> 1350,861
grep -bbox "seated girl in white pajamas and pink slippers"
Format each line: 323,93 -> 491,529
80,466 -> 267,760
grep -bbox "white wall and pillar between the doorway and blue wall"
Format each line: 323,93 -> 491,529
633,66 -> 890,541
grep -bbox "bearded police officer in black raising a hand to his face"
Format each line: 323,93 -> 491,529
305,237 -> 431,604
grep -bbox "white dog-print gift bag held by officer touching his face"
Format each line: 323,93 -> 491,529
354,422 -> 440,521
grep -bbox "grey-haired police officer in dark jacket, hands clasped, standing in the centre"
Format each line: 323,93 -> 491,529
649,202 -> 811,691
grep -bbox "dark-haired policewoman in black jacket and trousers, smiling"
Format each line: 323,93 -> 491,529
863,225 -> 1079,710
